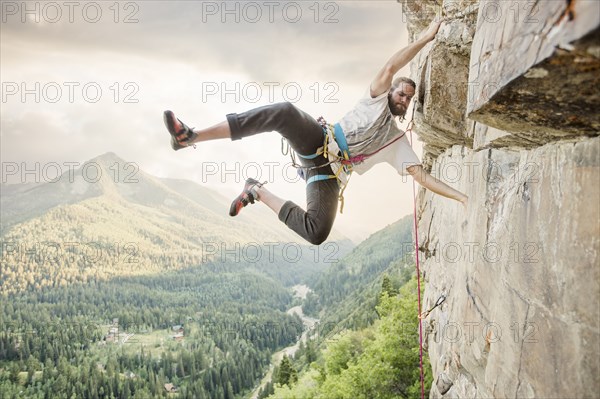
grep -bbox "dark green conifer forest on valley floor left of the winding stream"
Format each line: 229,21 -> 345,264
0,265 -> 302,399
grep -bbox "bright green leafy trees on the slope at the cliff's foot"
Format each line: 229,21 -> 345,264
262,278 -> 432,399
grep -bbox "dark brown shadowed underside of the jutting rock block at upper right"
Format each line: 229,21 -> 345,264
469,29 -> 600,147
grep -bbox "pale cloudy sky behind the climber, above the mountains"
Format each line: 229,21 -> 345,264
0,0 -> 432,241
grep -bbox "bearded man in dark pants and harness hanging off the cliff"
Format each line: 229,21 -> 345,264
164,20 -> 467,245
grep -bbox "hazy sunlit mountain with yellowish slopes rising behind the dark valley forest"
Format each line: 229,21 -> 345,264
0,153 -> 351,292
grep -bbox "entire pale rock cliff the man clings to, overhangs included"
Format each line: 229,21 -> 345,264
403,0 -> 600,398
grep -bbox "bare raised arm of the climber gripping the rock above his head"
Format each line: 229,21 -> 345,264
371,19 -> 443,98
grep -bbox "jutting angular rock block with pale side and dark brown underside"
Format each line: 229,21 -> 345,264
467,0 -> 600,147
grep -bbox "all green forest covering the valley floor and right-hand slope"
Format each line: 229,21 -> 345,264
0,218 -> 431,399
